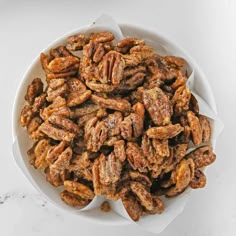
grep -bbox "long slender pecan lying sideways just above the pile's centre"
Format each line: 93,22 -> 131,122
91,94 -> 131,112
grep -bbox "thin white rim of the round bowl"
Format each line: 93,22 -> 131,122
11,22 -> 217,225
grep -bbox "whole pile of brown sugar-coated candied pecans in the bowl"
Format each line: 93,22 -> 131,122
20,32 -> 215,221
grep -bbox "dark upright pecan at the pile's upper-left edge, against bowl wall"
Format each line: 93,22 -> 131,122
25,78 -> 43,104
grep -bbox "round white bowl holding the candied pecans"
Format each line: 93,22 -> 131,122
12,24 -> 216,225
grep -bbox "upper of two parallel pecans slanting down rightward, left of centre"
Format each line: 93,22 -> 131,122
48,115 -> 81,135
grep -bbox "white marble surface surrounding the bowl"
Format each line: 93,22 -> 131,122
0,0 -> 236,236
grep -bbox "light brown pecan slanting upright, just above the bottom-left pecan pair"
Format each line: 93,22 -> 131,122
47,147 -> 72,187
